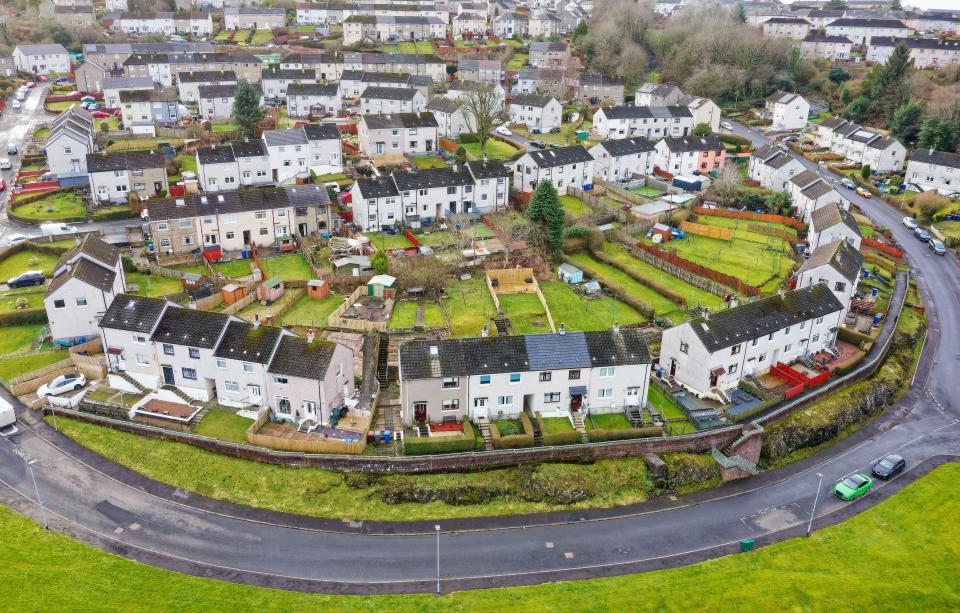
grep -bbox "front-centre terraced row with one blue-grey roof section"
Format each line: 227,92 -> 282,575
400,328 -> 650,426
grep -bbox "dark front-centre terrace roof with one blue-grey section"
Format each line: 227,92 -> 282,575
400,330 -> 650,380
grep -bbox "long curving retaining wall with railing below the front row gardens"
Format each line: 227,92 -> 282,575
43,272 -> 908,473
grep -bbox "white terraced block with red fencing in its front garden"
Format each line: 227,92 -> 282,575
660,284 -> 844,401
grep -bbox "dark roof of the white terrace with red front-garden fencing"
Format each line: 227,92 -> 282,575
689,283 -> 843,353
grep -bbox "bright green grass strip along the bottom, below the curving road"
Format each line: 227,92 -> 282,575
7,464 -> 960,613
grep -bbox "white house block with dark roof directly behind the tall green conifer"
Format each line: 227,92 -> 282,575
513,145 -> 594,194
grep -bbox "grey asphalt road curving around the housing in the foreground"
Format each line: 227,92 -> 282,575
0,119 -> 960,593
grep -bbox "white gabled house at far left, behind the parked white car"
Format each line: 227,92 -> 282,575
43,234 -> 126,342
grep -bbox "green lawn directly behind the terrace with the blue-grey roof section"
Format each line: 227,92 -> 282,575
540,281 -> 646,332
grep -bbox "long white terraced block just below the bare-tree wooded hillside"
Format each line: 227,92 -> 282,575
592,106 -> 694,140
